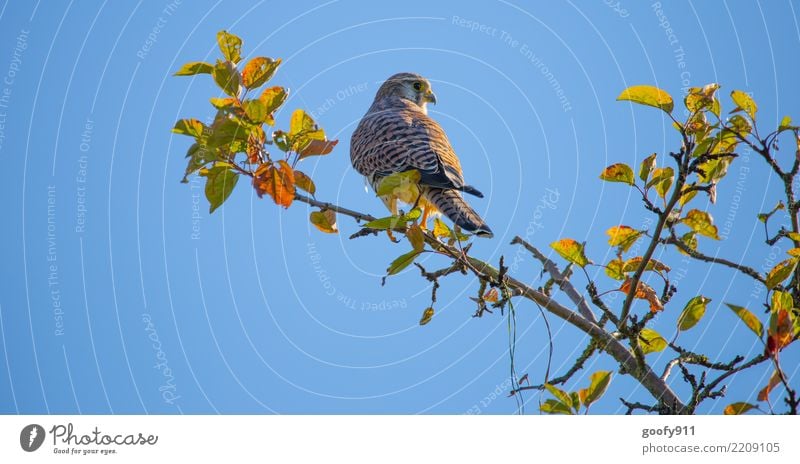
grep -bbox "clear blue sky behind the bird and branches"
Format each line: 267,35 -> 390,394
0,0 -> 800,414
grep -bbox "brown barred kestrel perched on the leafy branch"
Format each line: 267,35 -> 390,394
350,72 -> 494,238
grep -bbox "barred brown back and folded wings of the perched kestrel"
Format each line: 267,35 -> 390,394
350,104 -> 467,190
